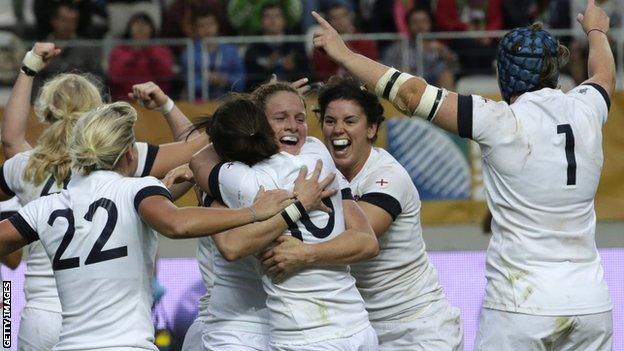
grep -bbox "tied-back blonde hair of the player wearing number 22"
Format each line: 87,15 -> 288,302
69,102 -> 137,175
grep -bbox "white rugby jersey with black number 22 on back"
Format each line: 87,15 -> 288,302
9,171 -> 170,351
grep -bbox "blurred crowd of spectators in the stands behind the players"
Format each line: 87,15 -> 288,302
0,0 -> 624,100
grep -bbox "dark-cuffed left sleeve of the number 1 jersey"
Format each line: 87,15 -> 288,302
457,95 -> 517,145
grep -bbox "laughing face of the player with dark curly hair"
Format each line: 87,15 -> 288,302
323,99 -> 377,179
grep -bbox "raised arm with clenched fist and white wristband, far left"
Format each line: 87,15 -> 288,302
0,43 -> 61,159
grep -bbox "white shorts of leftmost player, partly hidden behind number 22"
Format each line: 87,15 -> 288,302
17,307 -> 63,351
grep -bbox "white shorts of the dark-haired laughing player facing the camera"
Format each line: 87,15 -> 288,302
371,300 -> 464,351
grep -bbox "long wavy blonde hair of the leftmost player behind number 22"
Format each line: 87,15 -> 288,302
24,73 -> 103,186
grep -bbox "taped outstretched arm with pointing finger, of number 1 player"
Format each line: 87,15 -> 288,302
312,12 -> 458,134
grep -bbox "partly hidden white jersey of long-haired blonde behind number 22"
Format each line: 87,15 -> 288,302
0,143 -> 158,313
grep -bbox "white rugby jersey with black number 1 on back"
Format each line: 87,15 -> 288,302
458,84 -> 612,316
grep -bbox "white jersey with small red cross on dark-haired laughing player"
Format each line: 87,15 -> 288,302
351,147 -> 444,322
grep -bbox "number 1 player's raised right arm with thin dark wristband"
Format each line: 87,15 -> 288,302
576,0 -> 615,96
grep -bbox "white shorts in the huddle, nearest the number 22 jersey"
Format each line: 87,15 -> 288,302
190,319 -> 269,351
